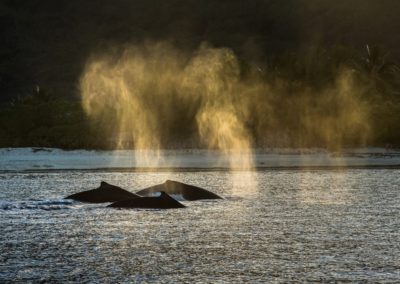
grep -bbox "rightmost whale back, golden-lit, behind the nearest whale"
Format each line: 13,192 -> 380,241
136,180 -> 222,201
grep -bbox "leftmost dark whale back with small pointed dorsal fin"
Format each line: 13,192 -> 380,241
65,181 -> 140,203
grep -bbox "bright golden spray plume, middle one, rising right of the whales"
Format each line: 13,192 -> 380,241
184,45 -> 253,169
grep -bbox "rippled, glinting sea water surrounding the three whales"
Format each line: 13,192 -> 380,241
0,169 -> 400,283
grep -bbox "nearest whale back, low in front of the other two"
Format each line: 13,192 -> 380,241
107,191 -> 186,209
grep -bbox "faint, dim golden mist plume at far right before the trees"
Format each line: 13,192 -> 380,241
295,69 -> 370,151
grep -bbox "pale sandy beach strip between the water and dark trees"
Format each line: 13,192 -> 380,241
0,148 -> 400,172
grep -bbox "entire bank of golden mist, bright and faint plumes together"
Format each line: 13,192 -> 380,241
81,42 -> 370,180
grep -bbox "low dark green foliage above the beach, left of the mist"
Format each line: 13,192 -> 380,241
0,90 -> 92,149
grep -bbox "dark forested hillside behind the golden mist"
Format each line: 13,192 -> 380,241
0,0 -> 400,149
